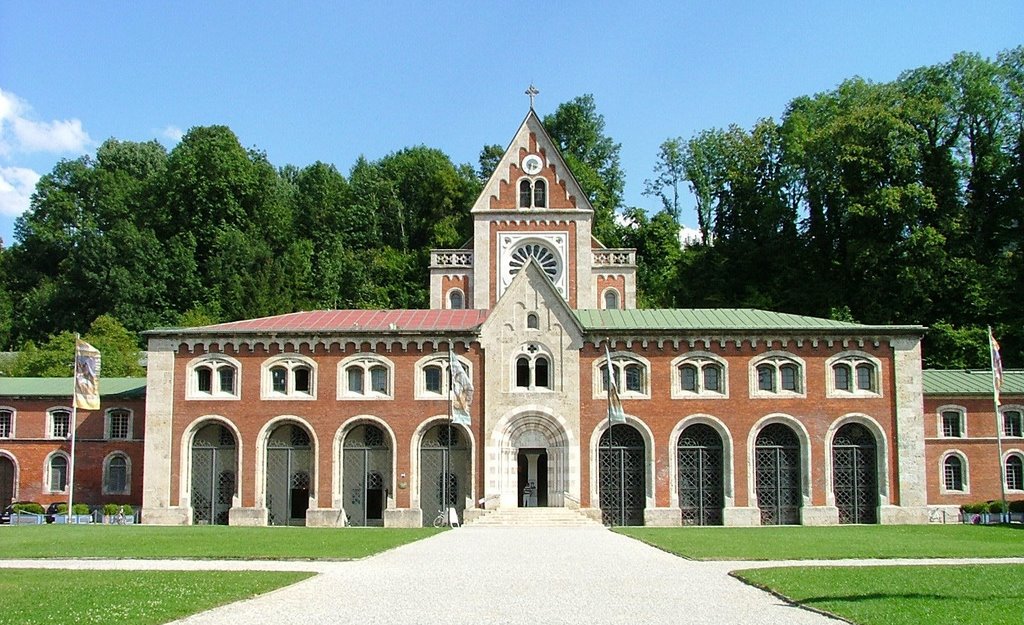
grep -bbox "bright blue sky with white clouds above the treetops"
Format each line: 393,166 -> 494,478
0,0 -> 1024,245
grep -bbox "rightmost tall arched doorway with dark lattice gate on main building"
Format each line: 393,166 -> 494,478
833,423 -> 879,524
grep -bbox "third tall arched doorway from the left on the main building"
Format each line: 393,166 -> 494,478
341,423 -> 391,526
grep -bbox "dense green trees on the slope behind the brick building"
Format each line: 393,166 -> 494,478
0,47 -> 1024,371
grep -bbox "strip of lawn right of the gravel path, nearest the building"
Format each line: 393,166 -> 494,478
615,525 -> 1024,559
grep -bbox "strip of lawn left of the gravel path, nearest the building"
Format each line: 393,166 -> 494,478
0,525 -> 443,557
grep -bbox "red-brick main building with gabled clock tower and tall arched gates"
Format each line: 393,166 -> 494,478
0,111 -> 1007,520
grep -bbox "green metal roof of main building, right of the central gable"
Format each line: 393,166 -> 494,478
575,308 -> 925,334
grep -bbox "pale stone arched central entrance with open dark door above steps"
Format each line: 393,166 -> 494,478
499,414 -> 571,507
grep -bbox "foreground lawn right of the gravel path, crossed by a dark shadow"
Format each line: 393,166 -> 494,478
733,565 -> 1024,625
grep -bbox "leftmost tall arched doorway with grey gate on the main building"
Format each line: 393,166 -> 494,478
191,423 -> 238,526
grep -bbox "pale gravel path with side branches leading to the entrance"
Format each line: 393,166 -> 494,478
0,527 -> 1024,625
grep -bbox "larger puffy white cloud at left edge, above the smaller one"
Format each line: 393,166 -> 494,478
0,89 -> 93,157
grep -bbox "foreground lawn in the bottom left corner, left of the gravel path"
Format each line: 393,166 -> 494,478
0,565 -> 313,625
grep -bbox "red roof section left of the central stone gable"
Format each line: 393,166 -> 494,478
193,309 -> 489,333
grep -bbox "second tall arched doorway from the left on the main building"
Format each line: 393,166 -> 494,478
266,423 -> 312,526
